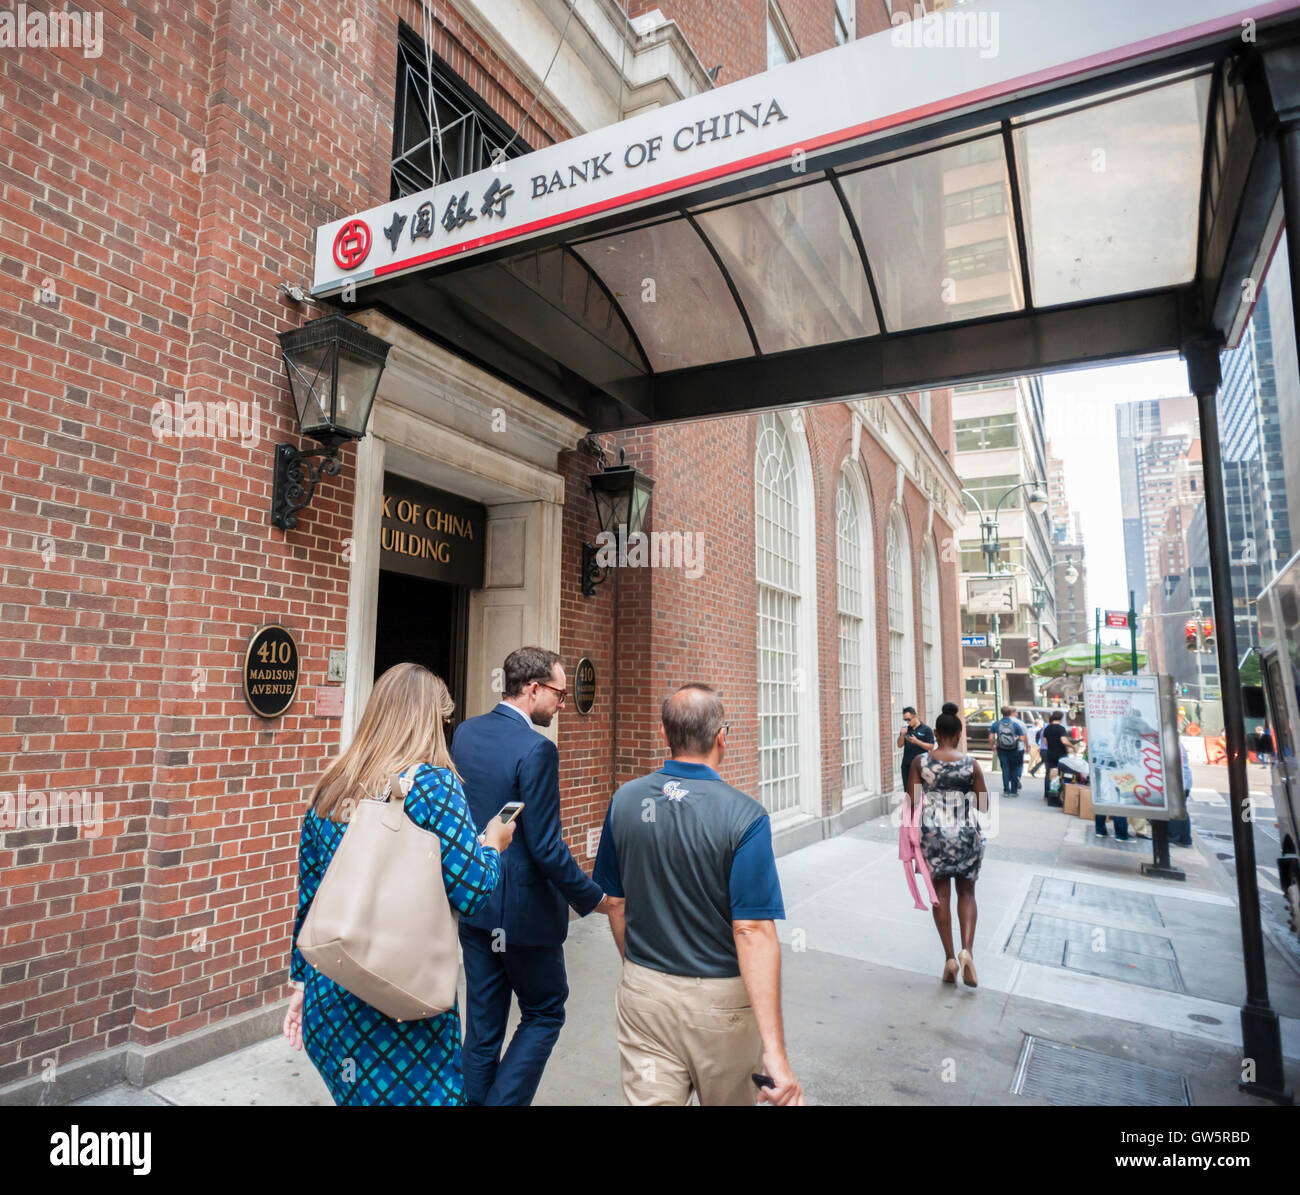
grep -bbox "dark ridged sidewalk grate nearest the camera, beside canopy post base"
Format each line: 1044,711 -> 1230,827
1011,1035 -> 1192,1108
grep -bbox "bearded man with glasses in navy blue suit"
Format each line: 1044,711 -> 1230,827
451,648 -> 610,1105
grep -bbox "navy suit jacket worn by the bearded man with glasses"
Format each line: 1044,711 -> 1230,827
451,706 -> 602,948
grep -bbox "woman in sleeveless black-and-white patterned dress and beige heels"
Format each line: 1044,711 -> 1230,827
906,714 -> 988,987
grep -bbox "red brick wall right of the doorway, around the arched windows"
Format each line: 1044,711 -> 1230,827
559,391 -> 961,866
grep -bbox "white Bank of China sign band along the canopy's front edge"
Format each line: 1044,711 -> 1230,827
312,0 -> 1292,300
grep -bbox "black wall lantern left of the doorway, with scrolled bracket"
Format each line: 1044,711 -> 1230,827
270,315 -> 390,531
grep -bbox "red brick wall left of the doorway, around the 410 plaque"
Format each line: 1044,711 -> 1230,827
0,0 -> 576,1084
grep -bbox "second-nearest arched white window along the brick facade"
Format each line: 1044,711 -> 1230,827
835,464 -> 880,800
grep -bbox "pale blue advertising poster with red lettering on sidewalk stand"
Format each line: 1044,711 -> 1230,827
1083,675 -> 1183,819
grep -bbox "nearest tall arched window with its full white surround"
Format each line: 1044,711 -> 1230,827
754,412 -> 820,822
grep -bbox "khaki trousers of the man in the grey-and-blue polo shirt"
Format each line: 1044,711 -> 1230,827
614,962 -> 763,1108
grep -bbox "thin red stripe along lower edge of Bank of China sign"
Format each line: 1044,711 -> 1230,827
351,0 -> 1295,285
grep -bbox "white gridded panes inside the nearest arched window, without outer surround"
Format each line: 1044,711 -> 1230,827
754,412 -> 802,817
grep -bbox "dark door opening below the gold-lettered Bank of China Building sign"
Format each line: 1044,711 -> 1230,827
374,568 -> 469,723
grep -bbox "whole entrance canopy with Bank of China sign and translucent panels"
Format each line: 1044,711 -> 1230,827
313,0 -> 1300,430
